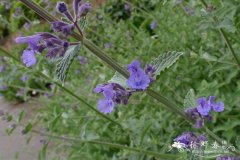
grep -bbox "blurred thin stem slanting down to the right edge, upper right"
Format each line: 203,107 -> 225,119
200,0 -> 240,67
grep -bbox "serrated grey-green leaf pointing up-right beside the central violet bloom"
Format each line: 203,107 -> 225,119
150,51 -> 183,77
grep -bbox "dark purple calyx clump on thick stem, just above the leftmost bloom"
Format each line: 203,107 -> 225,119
52,21 -> 74,37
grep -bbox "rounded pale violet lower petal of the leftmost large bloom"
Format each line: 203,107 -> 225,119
22,50 -> 37,67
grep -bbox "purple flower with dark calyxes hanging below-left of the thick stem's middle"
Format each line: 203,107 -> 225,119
94,83 -> 131,113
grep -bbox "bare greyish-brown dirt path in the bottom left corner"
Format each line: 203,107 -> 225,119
0,97 -> 42,160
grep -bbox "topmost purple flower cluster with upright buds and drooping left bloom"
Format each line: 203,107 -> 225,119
15,0 -> 91,67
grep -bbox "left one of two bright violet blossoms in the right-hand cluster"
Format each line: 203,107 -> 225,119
197,97 -> 211,116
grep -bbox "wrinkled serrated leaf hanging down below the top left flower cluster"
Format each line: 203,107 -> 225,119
56,45 -> 80,82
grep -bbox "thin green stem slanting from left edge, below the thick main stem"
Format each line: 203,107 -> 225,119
0,48 -> 122,129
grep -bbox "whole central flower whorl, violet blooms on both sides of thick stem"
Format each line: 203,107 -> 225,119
94,60 -> 155,113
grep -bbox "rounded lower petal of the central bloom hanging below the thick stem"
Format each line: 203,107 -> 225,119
98,99 -> 114,113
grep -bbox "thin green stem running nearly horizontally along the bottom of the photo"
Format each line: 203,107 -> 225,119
32,130 -> 179,159
